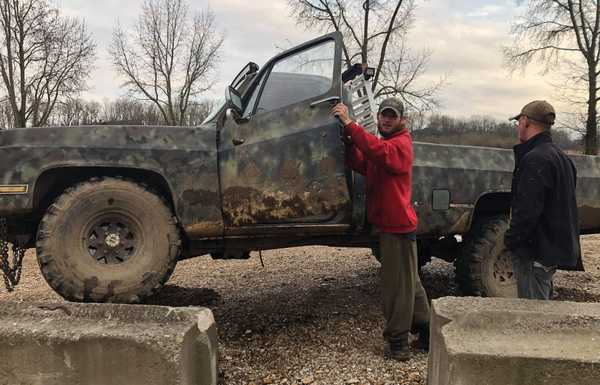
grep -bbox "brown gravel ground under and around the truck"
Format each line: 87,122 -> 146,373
0,235 -> 600,385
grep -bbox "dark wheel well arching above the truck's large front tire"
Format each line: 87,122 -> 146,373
33,167 -> 175,217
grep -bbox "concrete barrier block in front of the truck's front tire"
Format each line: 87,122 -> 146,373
0,302 -> 217,385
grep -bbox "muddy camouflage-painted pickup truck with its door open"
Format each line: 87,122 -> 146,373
0,33 -> 600,302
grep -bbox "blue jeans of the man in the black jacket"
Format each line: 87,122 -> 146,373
512,253 -> 556,300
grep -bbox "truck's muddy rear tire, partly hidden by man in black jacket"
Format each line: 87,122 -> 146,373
454,215 -> 517,298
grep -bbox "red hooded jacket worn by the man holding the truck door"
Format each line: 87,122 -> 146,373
344,122 -> 417,234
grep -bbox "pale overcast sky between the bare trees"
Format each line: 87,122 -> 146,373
58,0 -> 561,119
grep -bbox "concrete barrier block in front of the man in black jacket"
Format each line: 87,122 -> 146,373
427,297 -> 600,385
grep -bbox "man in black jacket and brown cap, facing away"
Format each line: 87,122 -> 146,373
504,100 -> 581,299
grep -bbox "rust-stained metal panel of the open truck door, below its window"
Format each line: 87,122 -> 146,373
220,106 -> 350,227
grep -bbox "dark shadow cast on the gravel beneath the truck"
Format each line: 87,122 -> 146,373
146,261 -> 456,341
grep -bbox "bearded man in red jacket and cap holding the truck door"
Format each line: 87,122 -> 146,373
332,98 -> 429,361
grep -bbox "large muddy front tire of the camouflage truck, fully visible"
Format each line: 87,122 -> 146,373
36,178 -> 181,303
